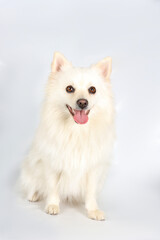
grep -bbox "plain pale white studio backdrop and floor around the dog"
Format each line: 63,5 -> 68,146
0,0 -> 160,240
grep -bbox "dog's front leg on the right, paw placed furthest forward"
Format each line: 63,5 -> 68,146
85,170 -> 105,220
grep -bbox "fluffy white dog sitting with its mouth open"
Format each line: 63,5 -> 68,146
21,53 -> 115,220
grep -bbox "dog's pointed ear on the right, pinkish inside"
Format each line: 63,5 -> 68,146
96,57 -> 112,80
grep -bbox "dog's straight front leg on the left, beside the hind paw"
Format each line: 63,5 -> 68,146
45,173 -> 60,215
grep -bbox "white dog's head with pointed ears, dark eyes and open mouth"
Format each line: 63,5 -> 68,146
47,52 -> 111,124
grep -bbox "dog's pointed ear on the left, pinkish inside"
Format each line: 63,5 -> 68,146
51,52 -> 71,73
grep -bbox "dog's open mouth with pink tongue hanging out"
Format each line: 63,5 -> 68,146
66,104 -> 90,124
